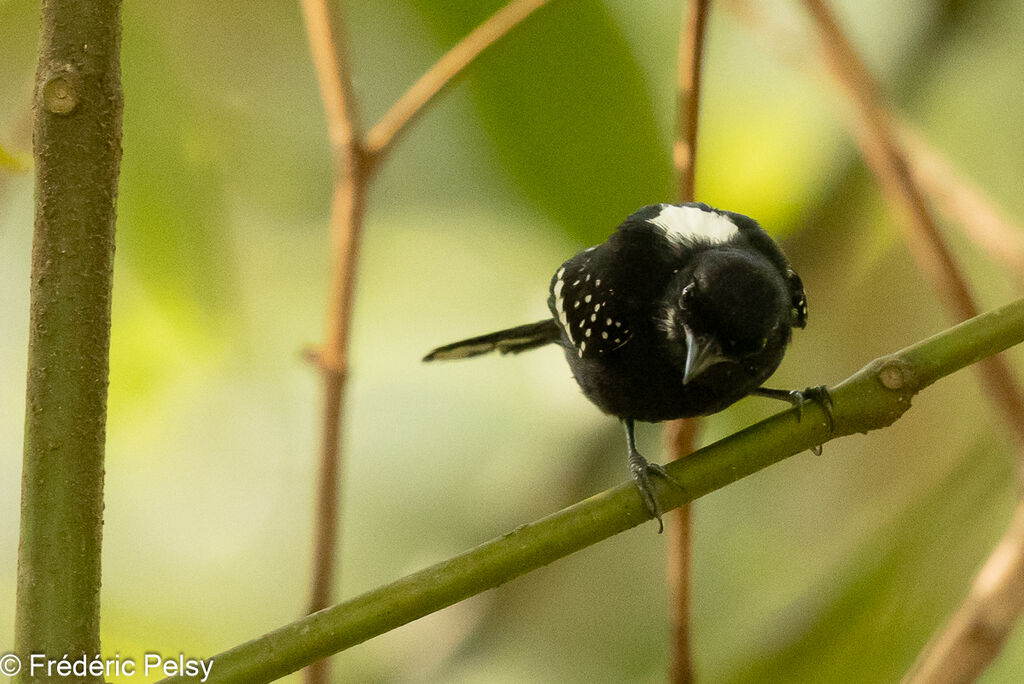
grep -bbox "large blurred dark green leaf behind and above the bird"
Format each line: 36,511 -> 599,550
414,0 -> 673,243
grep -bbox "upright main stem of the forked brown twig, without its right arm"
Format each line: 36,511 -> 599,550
302,0 -> 367,684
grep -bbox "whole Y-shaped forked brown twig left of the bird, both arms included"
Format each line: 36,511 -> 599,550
302,0 -> 550,684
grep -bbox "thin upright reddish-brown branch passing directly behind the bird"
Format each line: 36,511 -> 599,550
665,0 -> 711,684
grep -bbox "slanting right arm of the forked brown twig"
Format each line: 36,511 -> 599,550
366,0 -> 551,163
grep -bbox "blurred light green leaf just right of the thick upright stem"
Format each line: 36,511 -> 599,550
118,9 -> 233,315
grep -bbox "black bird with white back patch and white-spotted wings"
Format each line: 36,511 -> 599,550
423,203 -> 831,531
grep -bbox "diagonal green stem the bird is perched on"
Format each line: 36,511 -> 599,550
157,299 -> 1024,684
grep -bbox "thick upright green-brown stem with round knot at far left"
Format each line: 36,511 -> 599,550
14,0 -> 122,682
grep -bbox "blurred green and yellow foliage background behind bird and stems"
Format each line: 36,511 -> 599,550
0,0 -> 1024,682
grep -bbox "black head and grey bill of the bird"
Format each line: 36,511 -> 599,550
663,249 -> 794,384
